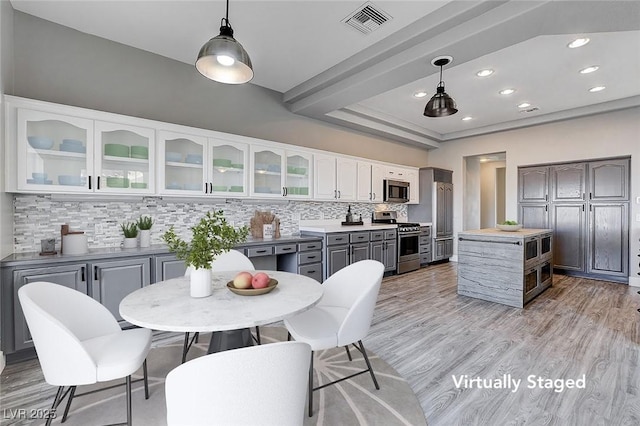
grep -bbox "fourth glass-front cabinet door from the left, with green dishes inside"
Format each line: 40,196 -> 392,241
207,138 -> 249,197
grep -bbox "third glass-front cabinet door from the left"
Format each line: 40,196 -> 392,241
158,130 -> 209,195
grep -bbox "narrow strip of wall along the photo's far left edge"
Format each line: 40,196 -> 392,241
0,0 -> 13,371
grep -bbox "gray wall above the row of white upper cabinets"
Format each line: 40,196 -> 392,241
7,11 -> 428,167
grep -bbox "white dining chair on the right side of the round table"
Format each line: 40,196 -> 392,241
284,260 -> 384,417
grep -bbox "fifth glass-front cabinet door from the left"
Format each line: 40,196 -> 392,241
251,145 -> 286,197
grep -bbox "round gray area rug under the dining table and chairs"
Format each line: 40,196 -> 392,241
0,327 -> 426,426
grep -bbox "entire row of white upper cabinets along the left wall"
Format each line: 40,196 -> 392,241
5,95 -> 418,203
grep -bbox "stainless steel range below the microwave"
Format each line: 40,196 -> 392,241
371,211 -> 420,274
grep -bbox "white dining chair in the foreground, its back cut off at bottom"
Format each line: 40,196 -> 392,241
165,342 -> 311,426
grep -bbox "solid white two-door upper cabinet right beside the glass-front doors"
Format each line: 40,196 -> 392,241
313,154 -> 358,201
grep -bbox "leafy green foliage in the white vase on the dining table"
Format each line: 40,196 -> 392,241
162,210 -> 249,269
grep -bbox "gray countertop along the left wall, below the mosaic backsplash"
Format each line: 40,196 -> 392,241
0,235 -> 321,267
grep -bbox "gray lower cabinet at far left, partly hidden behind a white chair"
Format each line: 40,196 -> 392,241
11,263 -> 87,351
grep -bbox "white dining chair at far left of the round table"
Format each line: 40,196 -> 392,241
18,281 -> 151,425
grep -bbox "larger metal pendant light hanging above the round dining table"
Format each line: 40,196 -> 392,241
196,0 -> 253,84
